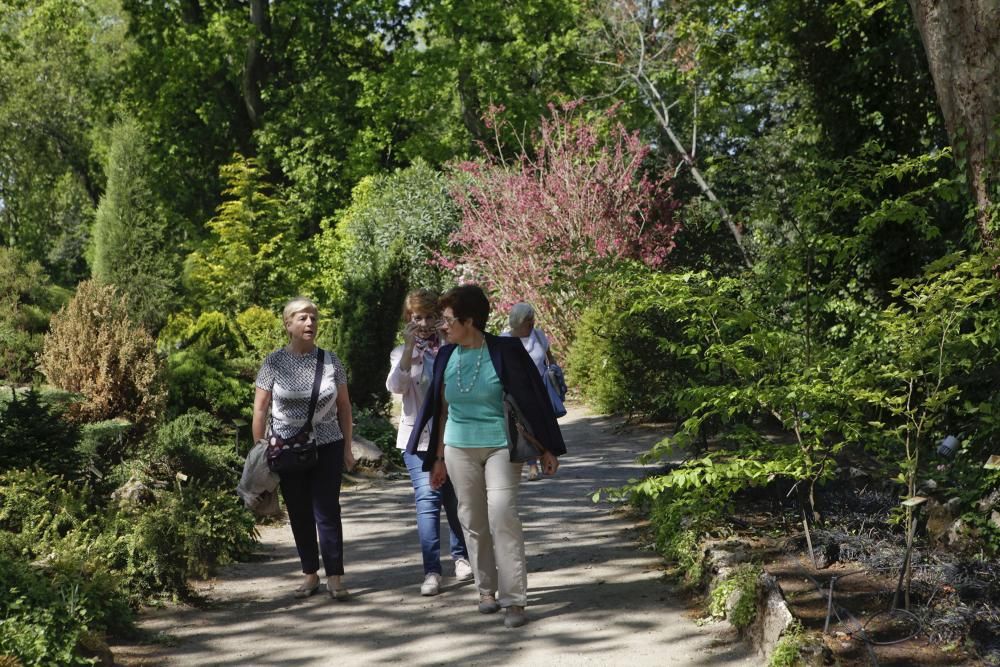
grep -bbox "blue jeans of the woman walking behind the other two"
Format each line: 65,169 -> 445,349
403,452 -> 469,574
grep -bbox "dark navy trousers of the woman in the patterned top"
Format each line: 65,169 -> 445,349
281,440 -> 344,577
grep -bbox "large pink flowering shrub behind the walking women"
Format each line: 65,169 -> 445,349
440,103 -> 678,349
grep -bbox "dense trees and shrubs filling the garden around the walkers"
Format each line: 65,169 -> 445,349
0,0 -> 1000,664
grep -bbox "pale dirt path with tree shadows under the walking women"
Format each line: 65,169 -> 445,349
113,409 -> 760,667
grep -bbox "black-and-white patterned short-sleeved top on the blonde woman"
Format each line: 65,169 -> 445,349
257,348 -> 347,445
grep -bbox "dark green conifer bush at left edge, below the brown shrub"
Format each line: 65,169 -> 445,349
0,389 -> 80,476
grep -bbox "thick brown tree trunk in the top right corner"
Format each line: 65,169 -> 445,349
909,0 -> 1000,248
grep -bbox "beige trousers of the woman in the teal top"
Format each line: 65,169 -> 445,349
444,446 -> 528,607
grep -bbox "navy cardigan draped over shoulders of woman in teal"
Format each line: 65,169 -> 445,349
406,334 -> 566,471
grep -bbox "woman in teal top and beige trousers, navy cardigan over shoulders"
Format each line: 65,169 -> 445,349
408,285 -> 566,628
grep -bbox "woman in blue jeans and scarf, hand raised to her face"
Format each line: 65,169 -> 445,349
385,289 -> 472,595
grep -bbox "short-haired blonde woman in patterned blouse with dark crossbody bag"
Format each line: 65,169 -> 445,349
253,298 -> 354,601
